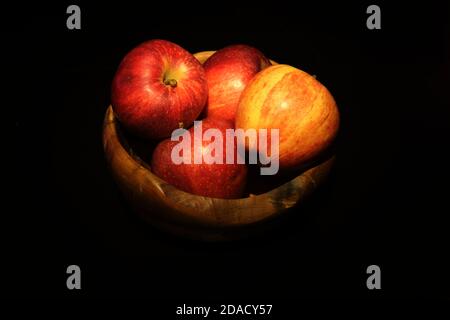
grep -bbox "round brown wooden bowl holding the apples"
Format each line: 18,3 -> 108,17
103,51 -> 334,241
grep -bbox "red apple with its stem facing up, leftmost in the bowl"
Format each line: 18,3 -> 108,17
111,40 -> 208,139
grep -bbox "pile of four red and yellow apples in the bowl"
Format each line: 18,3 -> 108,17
112,40 -> 339,198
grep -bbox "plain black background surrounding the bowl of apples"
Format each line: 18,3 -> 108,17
2,1 -> 450,302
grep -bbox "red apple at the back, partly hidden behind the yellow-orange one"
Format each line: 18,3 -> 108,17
203,45 -> 271,122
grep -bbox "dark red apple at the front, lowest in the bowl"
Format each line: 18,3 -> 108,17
151,119 -> 247,199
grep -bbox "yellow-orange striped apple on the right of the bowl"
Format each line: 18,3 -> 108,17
235,65 -> 339,169
